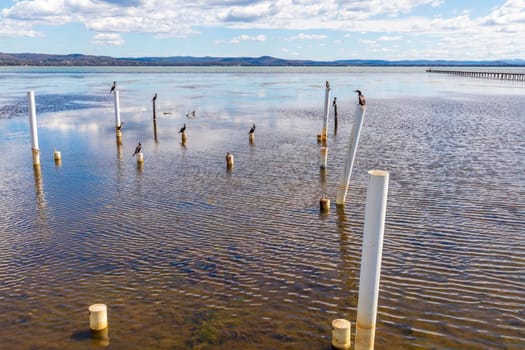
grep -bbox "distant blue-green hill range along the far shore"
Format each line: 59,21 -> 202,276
0,52 -> 525,67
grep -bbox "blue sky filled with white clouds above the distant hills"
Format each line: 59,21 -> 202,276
0,0 -> 525,60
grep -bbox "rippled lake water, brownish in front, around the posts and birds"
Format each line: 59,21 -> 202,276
0,67 -> 525,349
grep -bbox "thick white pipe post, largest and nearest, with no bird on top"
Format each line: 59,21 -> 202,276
355,170 -> 389,350
